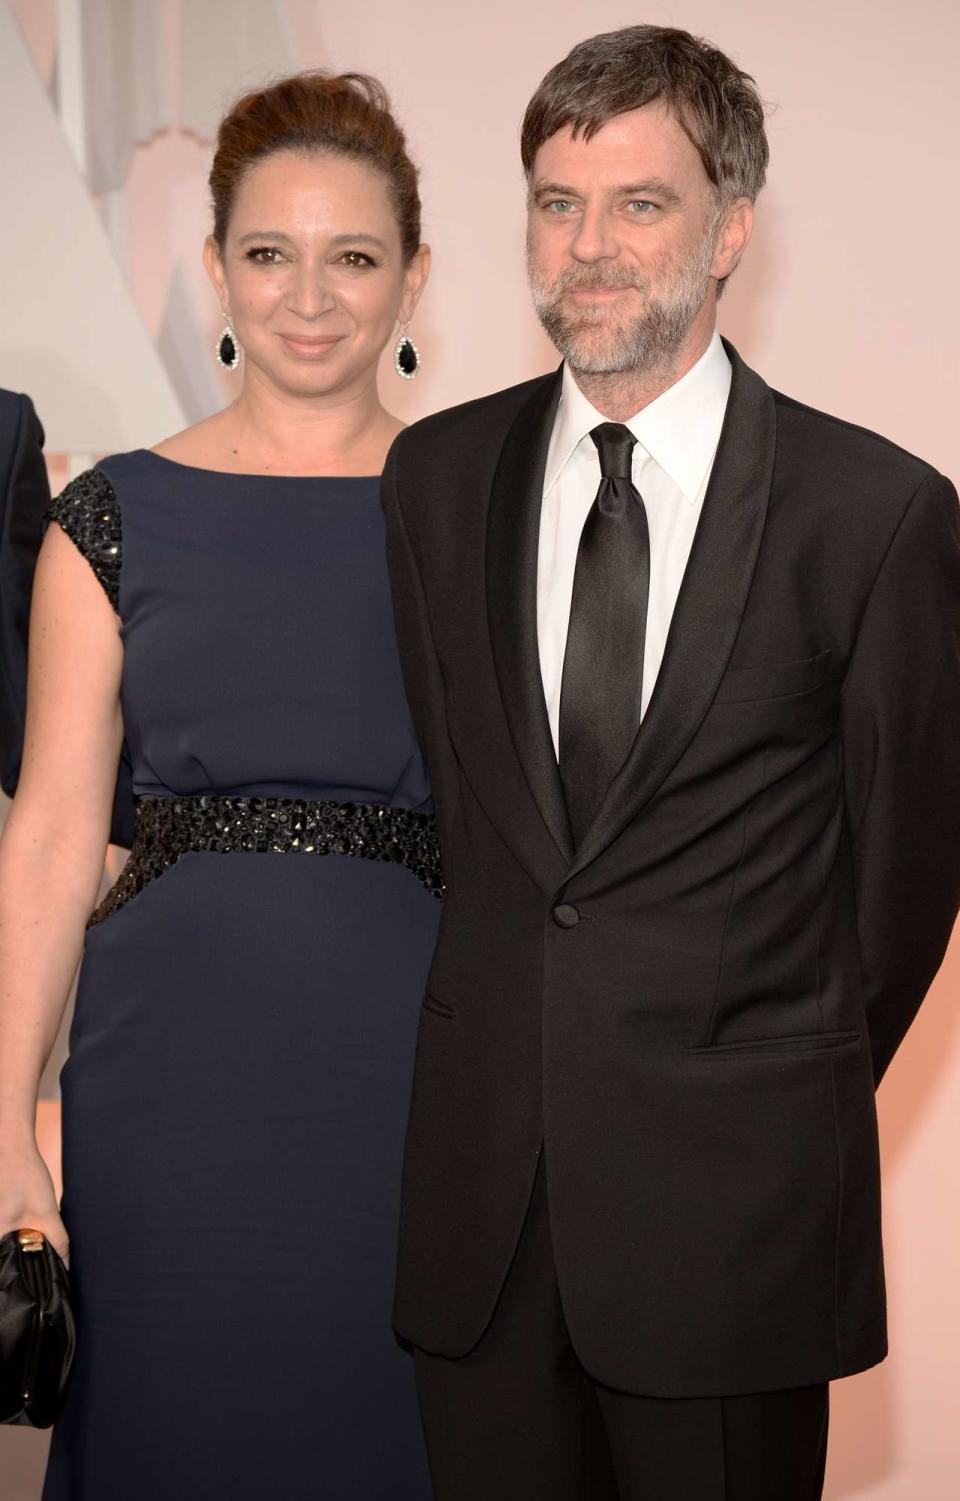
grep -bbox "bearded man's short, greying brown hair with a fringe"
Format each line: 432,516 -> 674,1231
521,26 -> 770,204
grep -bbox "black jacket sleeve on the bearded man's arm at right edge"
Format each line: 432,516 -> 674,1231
843,474 -> 960,1084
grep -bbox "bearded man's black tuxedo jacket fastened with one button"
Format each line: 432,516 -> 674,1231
384,345 -> 960,1396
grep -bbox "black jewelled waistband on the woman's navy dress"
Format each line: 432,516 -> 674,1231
89,797 -> 444,928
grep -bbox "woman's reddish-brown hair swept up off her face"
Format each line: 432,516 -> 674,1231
210,69 -> 420,261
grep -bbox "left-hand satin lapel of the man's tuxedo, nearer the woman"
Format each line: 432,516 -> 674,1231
486,371 -> 573,862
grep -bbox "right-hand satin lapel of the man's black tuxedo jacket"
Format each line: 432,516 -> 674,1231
567,341 -> 776,878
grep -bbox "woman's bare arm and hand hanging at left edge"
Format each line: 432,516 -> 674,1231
0,525 -> 123,1252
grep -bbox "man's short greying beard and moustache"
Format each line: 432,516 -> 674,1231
527,225 -> 716,375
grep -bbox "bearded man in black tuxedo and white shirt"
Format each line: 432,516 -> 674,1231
386,26 -> 960,1501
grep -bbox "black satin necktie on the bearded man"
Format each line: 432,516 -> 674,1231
560,422 -> 650,844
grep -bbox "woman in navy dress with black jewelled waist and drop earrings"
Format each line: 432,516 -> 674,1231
0,74 -> 440,1501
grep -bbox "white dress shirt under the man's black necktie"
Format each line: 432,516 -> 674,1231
537,330 -> 732,755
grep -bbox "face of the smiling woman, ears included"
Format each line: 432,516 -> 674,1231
204,152 -> 429,396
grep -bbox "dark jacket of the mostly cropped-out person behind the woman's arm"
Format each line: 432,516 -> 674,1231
0,390 -> 134,848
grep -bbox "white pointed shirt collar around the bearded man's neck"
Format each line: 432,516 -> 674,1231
543,329 -> 734,500
